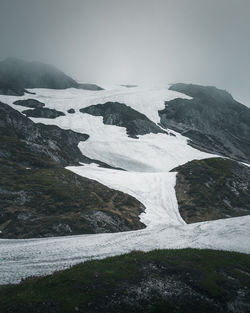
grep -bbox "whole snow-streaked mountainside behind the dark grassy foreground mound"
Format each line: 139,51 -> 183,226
0,58 -> 250,282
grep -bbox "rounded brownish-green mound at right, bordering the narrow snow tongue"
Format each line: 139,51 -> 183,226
173,158 -> 250,223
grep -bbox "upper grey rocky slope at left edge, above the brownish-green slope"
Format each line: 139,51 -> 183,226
0,103 -> 89,167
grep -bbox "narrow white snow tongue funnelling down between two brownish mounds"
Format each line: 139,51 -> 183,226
68,164 -> 185,227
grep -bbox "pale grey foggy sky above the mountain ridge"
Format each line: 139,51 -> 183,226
0,0 -> 250,106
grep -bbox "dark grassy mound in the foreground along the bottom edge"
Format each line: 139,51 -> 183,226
0,249 -> 250,313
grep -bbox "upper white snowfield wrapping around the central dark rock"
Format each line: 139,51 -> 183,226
0,87 -> 215,172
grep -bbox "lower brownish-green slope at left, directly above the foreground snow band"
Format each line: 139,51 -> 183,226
0,161 -> 145,238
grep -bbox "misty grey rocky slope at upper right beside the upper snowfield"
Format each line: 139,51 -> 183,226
159,84 -> 250,163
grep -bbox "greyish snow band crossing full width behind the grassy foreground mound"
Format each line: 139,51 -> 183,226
0,216 -> 250,284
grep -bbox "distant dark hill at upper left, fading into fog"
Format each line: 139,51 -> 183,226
0,58 -> 101,96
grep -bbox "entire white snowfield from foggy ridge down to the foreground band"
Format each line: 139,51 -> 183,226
0,86 -> 250,284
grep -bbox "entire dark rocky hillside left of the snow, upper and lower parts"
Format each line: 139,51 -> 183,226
0,103 -> 144,238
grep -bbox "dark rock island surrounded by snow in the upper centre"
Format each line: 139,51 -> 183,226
80,102 -> 166,138
